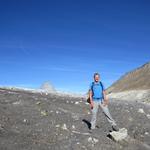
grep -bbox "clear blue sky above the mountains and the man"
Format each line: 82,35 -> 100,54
0,0 -> 150,92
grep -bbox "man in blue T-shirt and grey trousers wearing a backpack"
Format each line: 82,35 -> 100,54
89,73 -> 119,131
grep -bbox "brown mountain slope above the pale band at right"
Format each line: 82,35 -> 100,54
107,62 -> 150,93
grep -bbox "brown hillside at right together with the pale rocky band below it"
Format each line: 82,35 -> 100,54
107,62 -> 150,103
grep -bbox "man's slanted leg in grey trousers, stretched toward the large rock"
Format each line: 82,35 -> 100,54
100,104 -> 117,126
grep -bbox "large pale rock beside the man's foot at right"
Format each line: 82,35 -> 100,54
109,128 -> 128,142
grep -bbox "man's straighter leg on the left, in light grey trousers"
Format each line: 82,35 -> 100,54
91,101 -> 98,129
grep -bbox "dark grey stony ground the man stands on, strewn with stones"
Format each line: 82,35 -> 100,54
0,88 -> 150,150
